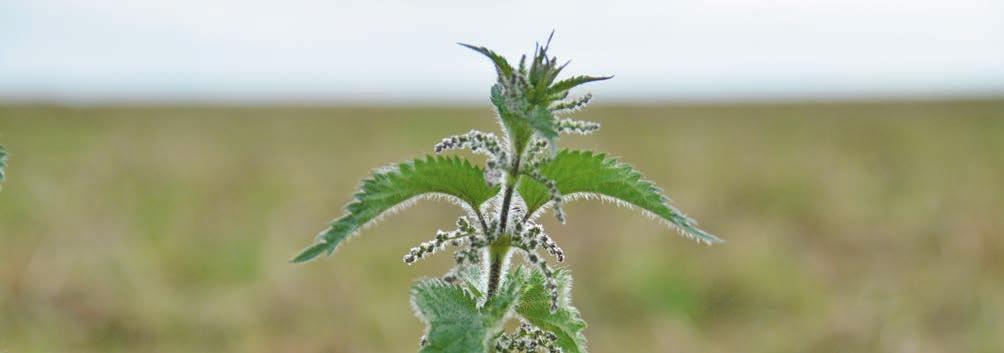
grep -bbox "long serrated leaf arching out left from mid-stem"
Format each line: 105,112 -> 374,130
292,156 -> 498,263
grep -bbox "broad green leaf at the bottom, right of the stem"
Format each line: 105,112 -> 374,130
516,270 -> 586,353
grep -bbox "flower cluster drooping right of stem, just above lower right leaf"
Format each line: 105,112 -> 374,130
512,222 -> 564,312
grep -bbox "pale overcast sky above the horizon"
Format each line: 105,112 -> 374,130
0,0 -> 1004,102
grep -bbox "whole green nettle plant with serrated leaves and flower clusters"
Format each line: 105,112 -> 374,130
292,33 -> 721,353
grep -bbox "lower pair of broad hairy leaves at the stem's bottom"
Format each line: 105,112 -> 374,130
412,268 -> 585,353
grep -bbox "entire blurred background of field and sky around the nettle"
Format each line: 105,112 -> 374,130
0,0 -> 1004,353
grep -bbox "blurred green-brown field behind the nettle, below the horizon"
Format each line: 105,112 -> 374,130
0,100 -> 1004,353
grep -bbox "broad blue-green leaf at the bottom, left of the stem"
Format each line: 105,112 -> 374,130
412,280 -> 488,353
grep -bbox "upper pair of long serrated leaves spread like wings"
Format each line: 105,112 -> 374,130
292,149 -> 721,263
